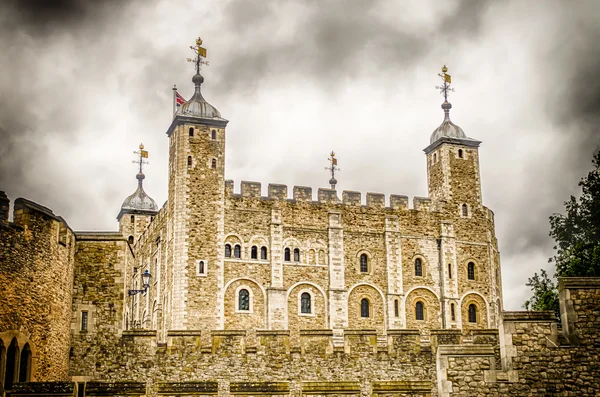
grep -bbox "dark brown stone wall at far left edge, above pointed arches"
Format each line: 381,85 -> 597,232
0,192 -> 75,383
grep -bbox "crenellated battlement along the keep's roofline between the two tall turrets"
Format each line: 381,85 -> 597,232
225,179 -> 434,212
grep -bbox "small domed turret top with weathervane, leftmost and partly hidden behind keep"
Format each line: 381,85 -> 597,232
117,144 -> 158,244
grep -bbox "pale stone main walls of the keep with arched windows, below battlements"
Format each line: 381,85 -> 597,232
121,181 -> 501,340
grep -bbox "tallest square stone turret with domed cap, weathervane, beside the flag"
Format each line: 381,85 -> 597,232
167,39 -> 228,330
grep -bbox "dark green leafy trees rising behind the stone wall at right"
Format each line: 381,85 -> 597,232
523,152 -> 600,313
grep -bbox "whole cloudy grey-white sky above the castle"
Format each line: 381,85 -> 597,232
0,0 -> 600,310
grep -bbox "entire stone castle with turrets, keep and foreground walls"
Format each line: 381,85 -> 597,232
0,47 -> 600,396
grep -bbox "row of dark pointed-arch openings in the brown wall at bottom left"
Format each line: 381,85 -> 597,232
0,338 -> 32,390
